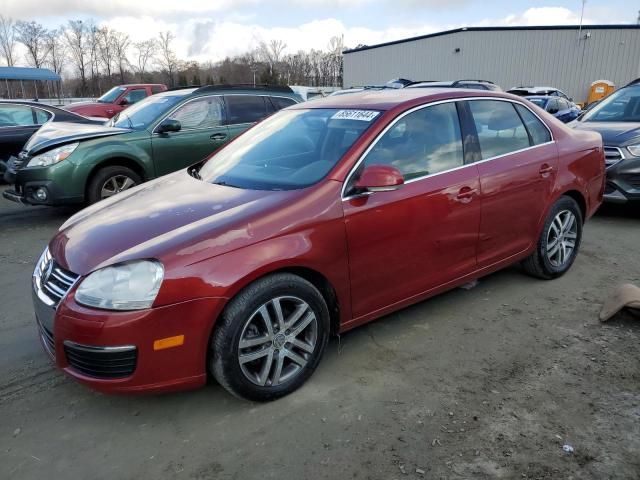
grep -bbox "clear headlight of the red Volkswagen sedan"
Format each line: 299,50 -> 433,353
76,260 -> 164,310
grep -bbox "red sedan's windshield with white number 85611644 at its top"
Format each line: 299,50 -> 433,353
199,109 -> 380,190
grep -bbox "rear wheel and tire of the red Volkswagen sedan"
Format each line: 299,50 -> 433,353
522,196 -> 583,280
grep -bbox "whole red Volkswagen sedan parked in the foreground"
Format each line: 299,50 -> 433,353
33,89 -> 604,400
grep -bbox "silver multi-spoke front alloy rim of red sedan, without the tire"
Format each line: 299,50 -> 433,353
238,296 -> 318,387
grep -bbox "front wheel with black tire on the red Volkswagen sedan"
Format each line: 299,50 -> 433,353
209,273 -> 329,402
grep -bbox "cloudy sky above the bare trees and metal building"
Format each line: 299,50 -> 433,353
0,0 -> 640,61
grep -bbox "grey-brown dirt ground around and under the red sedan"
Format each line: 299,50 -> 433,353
0,188 -> 640,480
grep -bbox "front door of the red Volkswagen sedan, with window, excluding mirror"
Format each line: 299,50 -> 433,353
343,102 -> 480,318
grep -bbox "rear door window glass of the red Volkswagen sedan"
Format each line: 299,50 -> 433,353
469,100 -> 531,160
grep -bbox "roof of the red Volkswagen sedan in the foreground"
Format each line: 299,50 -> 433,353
289,88 -> 518,110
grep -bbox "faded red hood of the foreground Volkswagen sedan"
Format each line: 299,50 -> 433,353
49,170 -> 301,275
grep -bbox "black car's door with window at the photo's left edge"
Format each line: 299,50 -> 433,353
0,104 -> 41,160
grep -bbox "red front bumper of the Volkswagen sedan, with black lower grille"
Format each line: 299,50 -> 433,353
33,289 -> 225,393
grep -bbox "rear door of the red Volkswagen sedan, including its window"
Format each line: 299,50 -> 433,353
467,99 -> 558,267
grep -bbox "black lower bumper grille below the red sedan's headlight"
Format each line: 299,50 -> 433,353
64,341 -> 138,379
